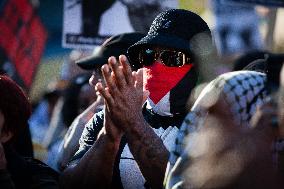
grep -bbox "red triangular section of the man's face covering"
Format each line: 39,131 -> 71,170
144,61 -> 193,104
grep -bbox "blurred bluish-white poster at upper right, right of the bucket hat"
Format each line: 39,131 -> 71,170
211,0 -> 263,55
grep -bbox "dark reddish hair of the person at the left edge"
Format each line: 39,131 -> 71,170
0,75 -> 31,136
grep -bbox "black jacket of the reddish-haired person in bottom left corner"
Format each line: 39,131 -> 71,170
0,146 -> 59,189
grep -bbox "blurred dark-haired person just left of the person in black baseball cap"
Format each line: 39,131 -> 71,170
42,73 -> 96,170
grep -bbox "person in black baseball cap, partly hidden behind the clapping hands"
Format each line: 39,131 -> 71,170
58,32 -> 144,170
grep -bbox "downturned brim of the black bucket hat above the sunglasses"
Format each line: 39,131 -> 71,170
127,33 -> 190,62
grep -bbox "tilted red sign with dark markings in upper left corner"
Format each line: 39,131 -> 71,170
0,0 -> 47,88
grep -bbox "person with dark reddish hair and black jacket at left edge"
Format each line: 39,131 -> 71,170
0,75 -> 58,188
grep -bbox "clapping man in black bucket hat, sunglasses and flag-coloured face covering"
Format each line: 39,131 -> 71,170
63,9 -> 212,188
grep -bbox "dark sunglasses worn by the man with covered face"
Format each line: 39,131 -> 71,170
138,48 -> 190,67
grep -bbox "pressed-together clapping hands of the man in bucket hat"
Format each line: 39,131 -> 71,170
96,55 -> 144,130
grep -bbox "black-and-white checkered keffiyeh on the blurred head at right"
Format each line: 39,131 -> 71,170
170,71 -> 267,179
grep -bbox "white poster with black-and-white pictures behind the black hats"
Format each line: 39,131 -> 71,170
62,0 -> 178,49
